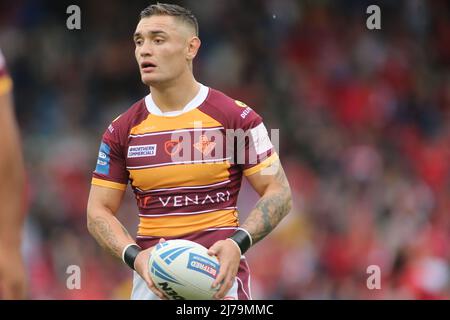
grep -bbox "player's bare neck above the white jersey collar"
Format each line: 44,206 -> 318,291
150,72 -> 200,112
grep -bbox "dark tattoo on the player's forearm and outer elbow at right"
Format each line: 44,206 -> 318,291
242,163 -> 292,243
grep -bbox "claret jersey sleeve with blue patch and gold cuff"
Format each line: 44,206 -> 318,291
92,120 -> 129,190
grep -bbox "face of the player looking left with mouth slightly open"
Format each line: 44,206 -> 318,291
134,16 -> 192,86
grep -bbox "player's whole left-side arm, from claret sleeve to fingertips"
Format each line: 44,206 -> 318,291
87,119 -> 164,299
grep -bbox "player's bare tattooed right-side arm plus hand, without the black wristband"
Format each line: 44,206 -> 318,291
210,159 -> 292,299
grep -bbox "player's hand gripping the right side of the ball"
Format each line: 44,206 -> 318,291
208,240 -> 241,299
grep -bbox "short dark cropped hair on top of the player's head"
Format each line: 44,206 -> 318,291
139,2 -> 198,36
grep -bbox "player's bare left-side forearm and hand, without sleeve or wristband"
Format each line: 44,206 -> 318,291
87,185 -> 165,299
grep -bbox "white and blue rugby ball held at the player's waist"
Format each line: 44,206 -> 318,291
149,239 -> 220,300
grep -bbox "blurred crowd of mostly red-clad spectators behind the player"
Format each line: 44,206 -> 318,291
0,0 -> 450,299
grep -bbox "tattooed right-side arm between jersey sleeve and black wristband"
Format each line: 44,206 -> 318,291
241,160 -> 292,244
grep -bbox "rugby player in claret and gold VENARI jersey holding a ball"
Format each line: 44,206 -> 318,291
87,3 -> 291,299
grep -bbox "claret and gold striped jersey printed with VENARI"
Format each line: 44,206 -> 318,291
92,85 -> 278,248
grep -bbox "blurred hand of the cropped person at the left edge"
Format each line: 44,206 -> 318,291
0,247 -> 27,300
